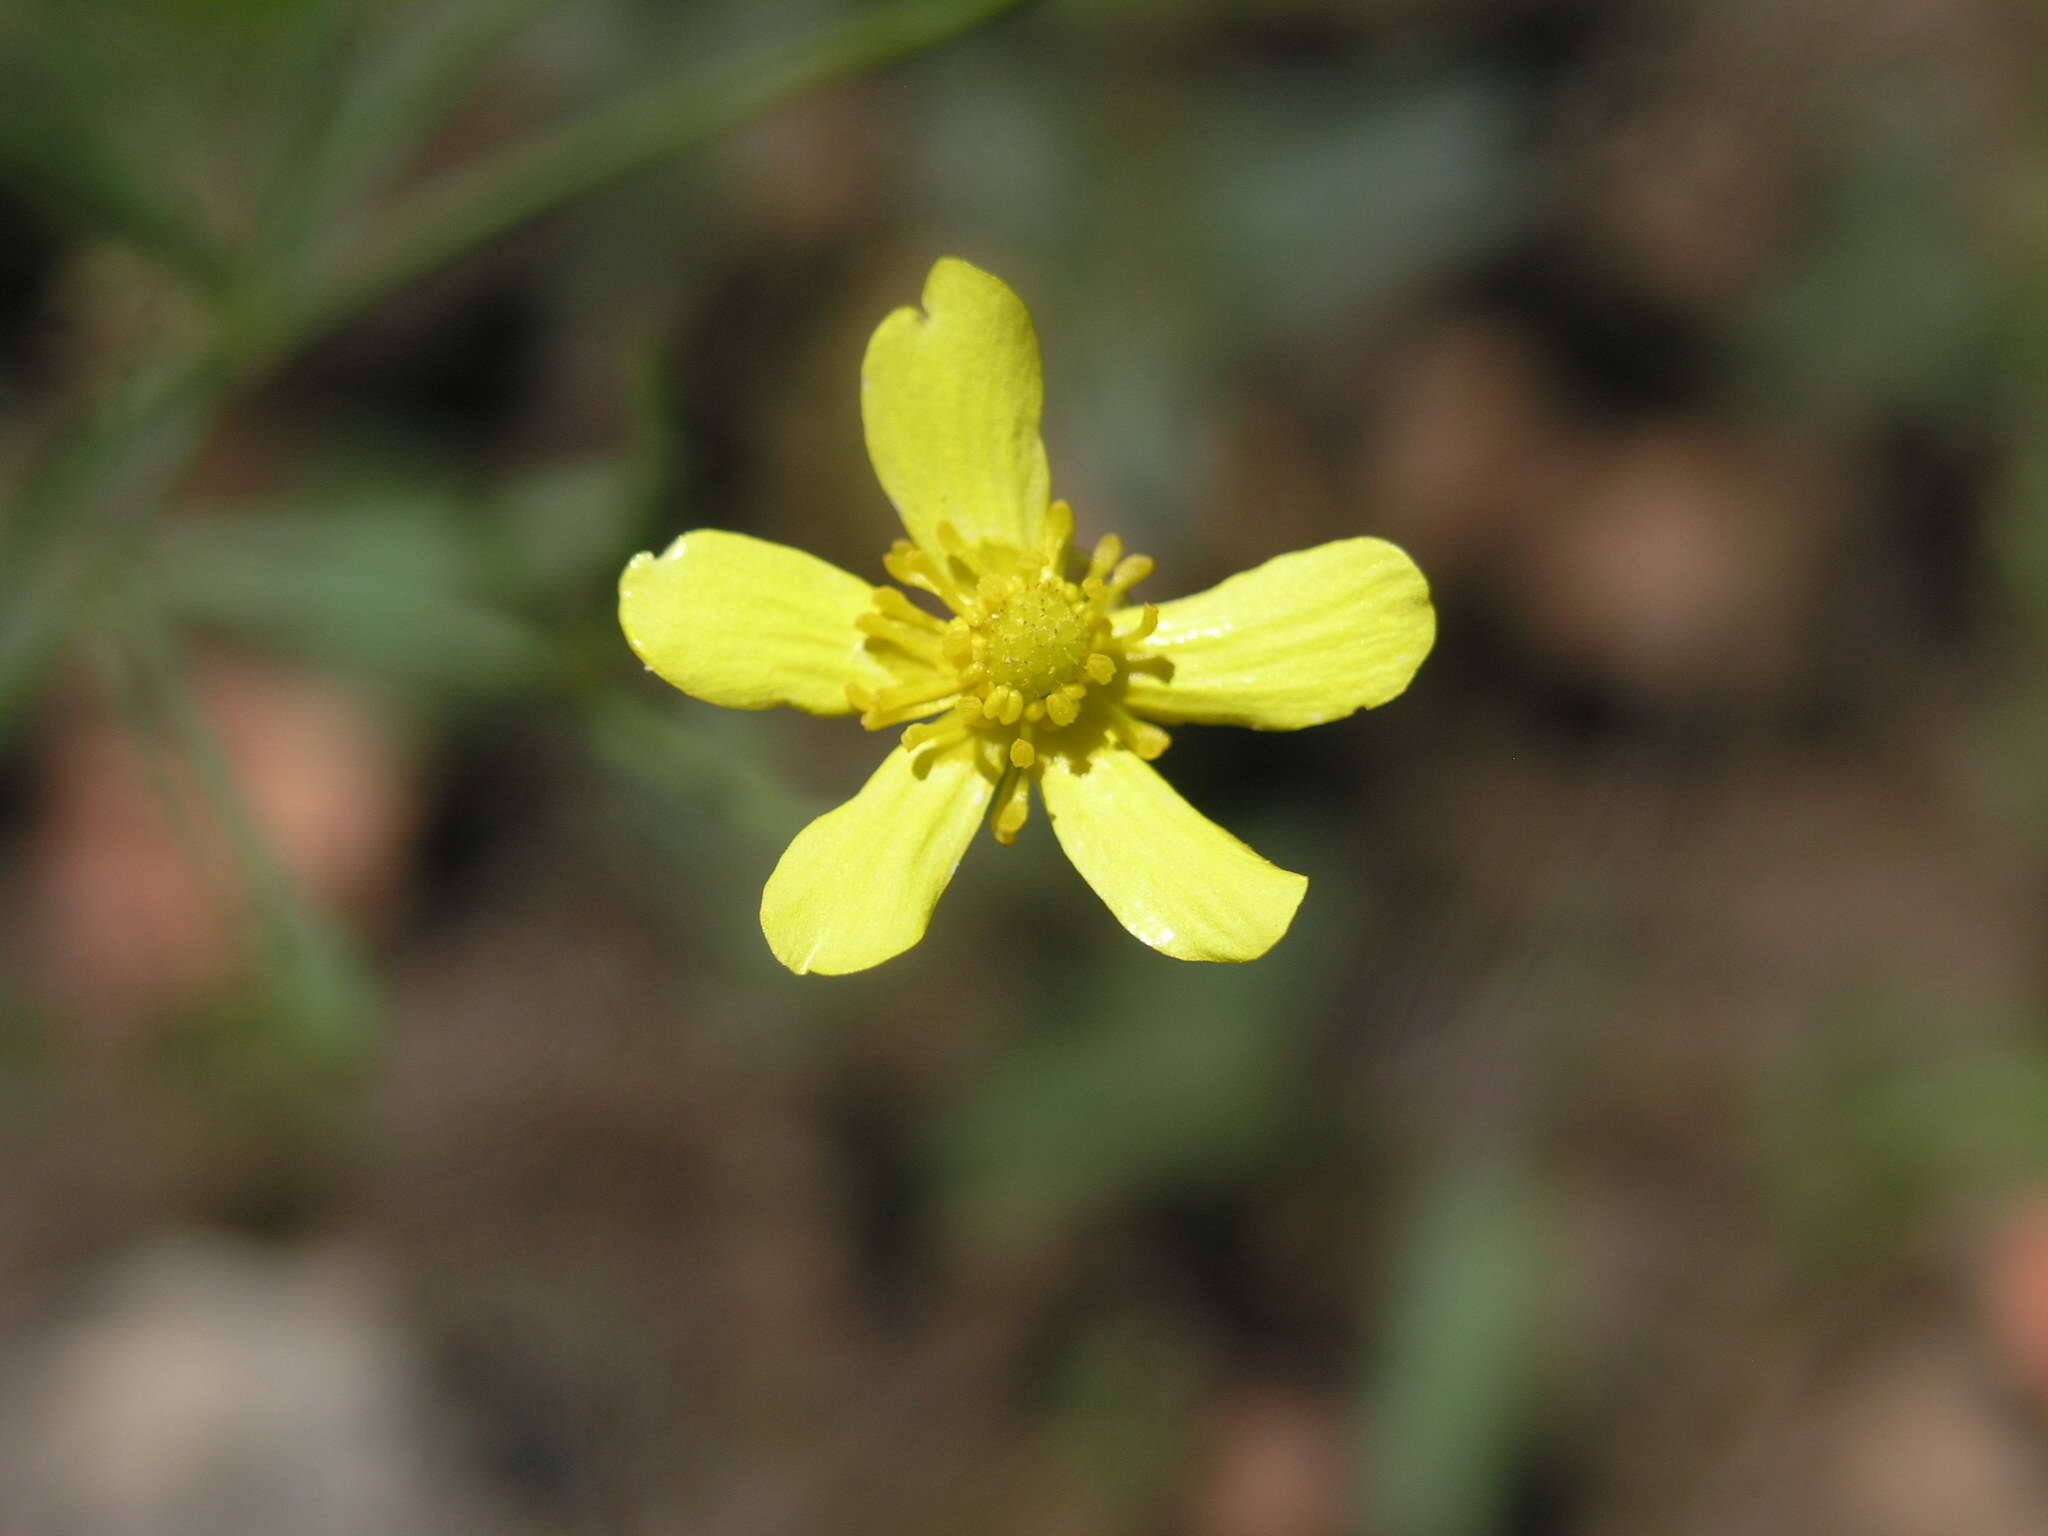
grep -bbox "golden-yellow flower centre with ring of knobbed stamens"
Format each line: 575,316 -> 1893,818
848,502 -> 1167,844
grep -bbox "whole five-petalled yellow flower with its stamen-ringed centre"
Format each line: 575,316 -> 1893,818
618,258 -> 1436,975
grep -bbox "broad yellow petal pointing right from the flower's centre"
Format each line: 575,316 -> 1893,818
1118,539 -> 1436,731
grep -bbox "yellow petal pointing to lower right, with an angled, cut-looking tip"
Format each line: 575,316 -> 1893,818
1038,745 -> 1309,961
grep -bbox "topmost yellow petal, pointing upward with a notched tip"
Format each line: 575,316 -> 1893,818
860,256 -> 1051,557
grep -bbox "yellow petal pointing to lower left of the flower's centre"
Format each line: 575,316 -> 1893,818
762,748 -> 993,977
